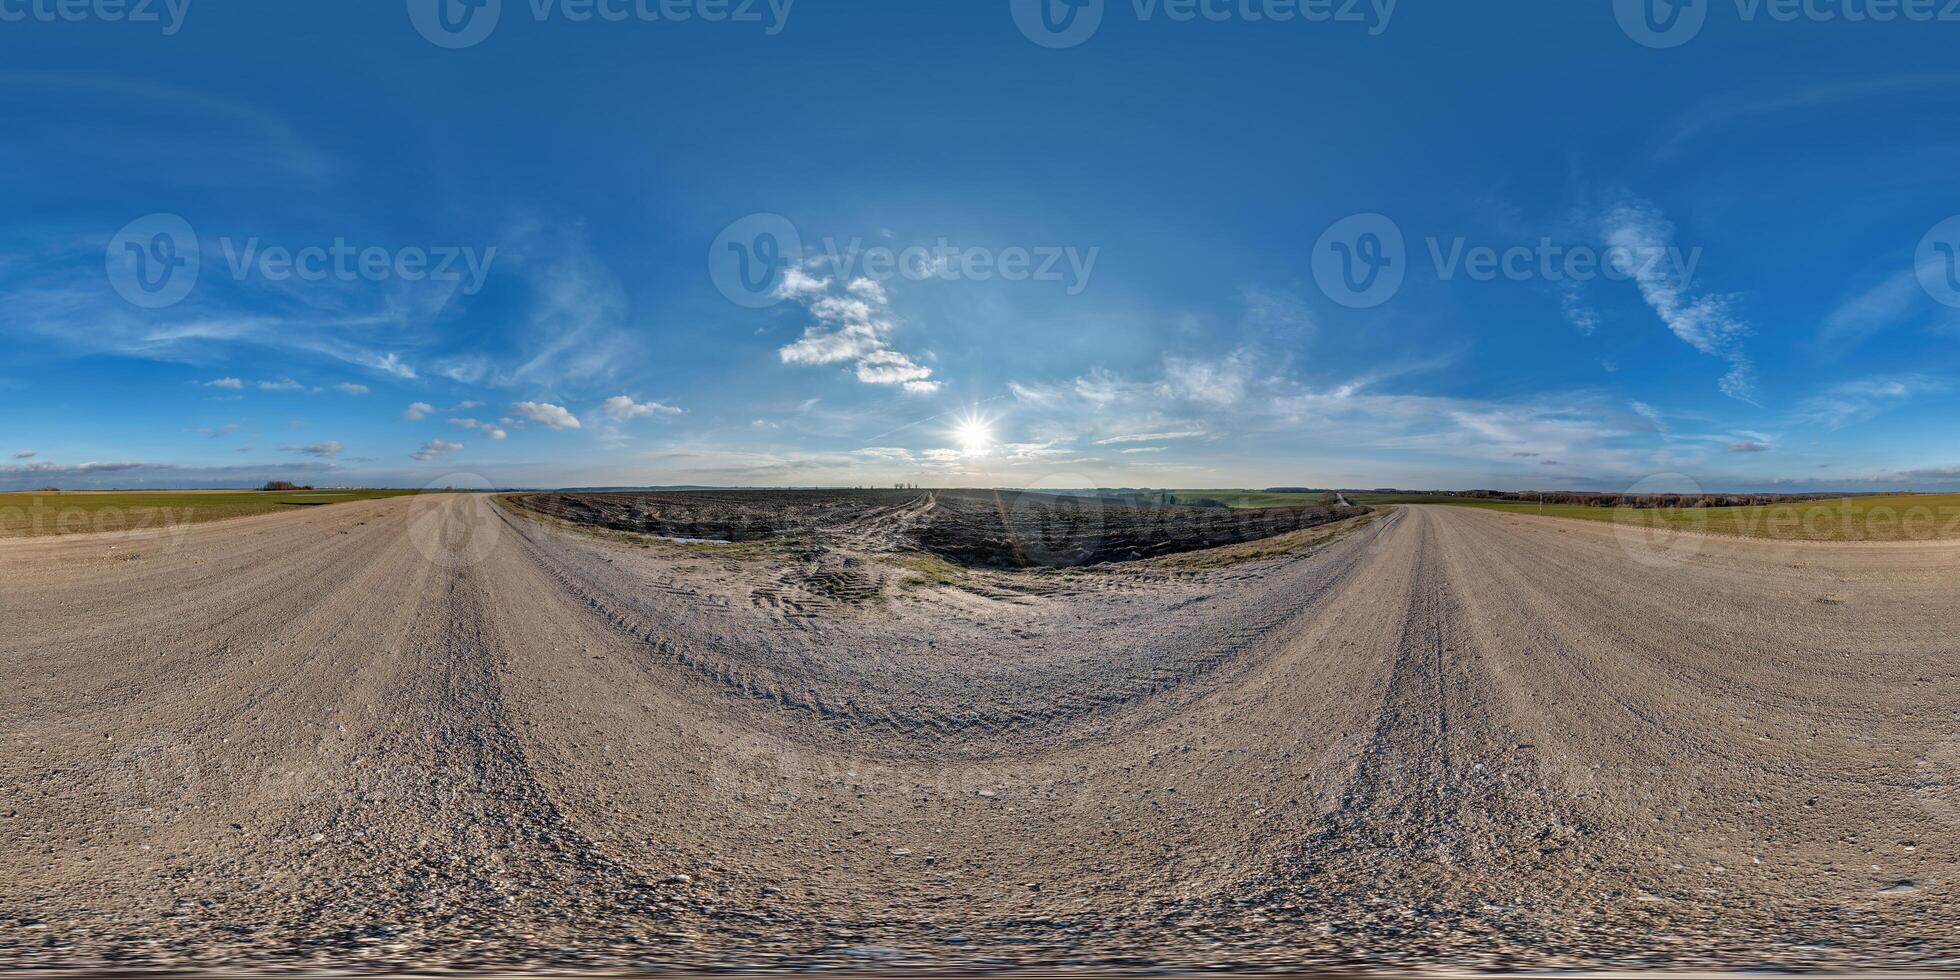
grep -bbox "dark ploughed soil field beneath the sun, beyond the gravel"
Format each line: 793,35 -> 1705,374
517,490 -> 1368,568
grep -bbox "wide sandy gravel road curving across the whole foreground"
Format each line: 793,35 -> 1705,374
0,496 -> 1960,966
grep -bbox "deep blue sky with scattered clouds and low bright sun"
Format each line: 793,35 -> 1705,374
0,0 -> 1960,492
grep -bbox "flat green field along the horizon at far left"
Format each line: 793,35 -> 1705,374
0,490 -> 414,537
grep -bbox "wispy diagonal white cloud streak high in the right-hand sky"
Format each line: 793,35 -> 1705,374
1603,202 -> 1756,404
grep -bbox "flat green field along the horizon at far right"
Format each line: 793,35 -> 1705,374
1350,494 -> 1960,541
